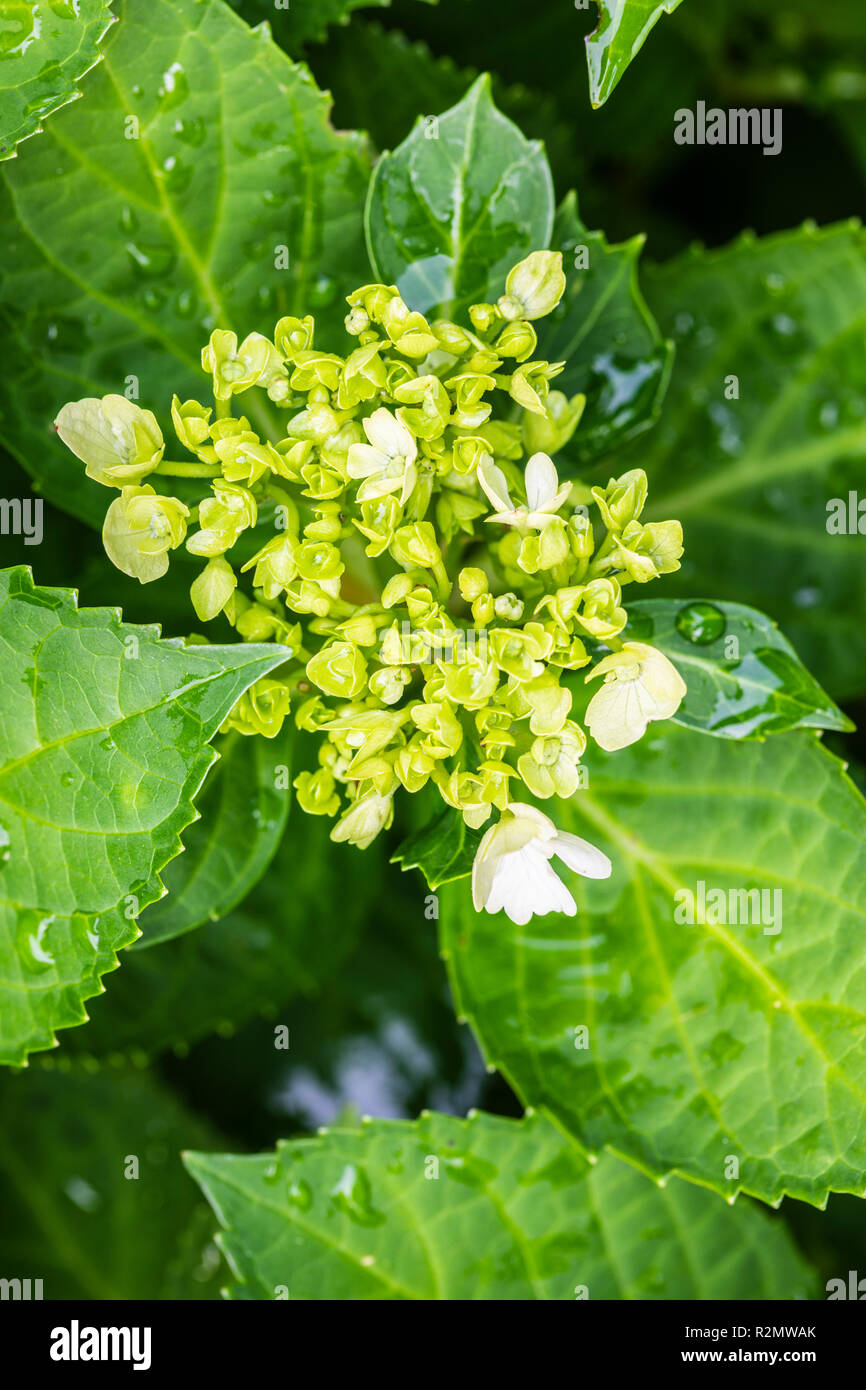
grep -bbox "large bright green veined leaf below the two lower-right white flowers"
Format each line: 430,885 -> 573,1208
441,724 -> 866,1205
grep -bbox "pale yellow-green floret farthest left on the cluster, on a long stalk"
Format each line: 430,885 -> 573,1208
54,396 -> 165,488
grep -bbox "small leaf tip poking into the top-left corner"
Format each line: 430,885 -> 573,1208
0,0 -> 114,160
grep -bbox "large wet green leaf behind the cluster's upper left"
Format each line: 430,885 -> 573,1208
0,0 -> 370,527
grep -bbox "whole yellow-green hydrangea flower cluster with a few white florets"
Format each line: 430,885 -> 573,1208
56,252 -> 685,910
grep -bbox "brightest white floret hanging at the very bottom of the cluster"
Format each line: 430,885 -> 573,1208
473,802 -> 610,927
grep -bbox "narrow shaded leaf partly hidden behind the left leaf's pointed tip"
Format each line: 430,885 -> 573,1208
135,726 -> 292,951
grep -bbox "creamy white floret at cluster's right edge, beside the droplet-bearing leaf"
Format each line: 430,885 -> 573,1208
587,642 -> 685,753
